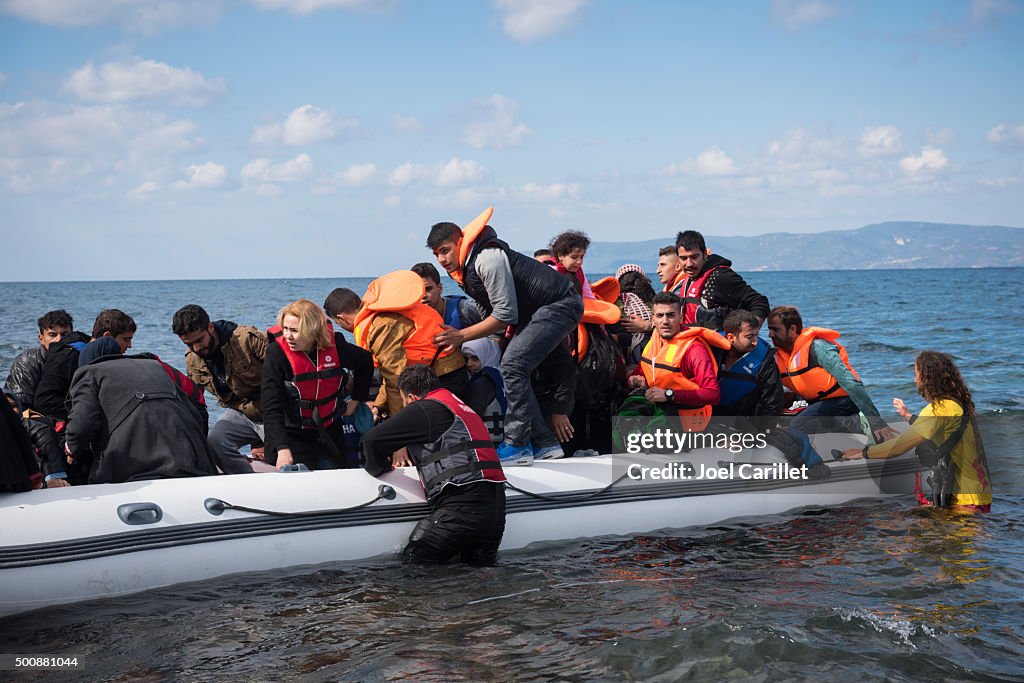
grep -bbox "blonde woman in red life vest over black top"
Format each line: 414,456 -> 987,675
262,299 -> 374,469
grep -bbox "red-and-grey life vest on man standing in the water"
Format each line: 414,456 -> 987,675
409,389 -> 505,499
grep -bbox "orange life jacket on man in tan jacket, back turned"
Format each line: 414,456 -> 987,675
352,270 -> 456,368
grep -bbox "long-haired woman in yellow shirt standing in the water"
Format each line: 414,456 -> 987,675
843,351 -> 992,512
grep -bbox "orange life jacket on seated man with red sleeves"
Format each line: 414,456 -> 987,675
640,328 -> 730,431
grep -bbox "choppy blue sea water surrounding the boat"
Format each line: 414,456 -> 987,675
0,269 -> 1024,681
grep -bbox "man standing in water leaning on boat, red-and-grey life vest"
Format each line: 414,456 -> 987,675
362,366 -> 505,564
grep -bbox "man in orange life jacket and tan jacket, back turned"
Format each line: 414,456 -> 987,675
324,270 -> 469,415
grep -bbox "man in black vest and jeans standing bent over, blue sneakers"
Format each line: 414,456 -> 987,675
427,208 -> 583,465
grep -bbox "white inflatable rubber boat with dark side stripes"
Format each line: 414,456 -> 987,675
0,435 -> 916,616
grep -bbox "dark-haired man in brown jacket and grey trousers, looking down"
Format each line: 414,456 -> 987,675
171,303 -> 266,474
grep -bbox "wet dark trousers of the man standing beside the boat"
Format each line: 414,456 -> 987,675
401,482 -> 505,565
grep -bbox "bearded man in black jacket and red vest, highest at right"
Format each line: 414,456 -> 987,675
676,230 -> 771,330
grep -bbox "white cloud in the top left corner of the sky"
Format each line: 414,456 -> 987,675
0,0 -> 221,33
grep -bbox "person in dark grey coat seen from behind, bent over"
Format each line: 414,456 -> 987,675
67,354 -> 217,483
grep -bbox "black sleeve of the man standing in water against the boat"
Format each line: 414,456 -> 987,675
362,398 -> 455,476
